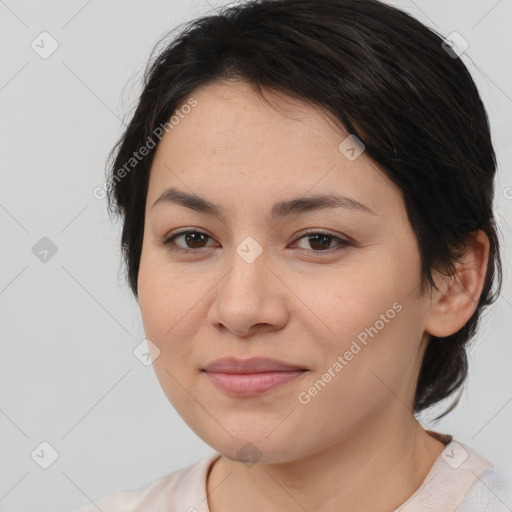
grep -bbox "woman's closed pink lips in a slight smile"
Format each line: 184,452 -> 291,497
203,357 -> 307,396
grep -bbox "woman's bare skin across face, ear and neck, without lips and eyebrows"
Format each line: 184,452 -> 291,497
138,82 -> 488,512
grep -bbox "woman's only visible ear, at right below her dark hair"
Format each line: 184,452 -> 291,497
425,230 -> 489,338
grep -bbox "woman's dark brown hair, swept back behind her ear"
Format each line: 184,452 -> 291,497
107,0 -> 502,418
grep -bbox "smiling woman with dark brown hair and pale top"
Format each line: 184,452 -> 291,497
73,0 -> 511,512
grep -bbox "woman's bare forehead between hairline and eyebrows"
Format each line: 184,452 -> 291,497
148,82 -> 399,219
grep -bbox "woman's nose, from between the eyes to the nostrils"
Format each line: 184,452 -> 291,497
208,244 -> 290,338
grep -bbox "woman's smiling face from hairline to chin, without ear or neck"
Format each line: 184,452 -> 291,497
138,82 -> 429,463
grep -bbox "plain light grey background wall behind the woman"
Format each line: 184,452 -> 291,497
0,0 -> 512,512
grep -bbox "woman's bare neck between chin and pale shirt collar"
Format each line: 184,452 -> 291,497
207,409 -> 444,512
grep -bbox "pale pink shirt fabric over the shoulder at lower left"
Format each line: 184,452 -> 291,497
71,454 -> 216,512
